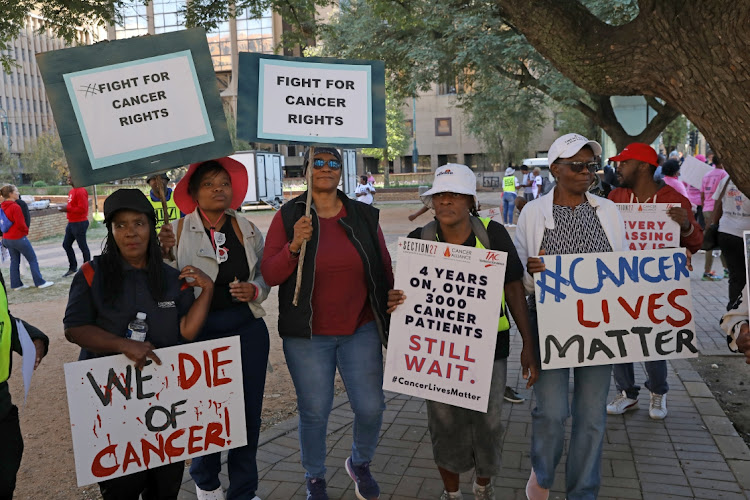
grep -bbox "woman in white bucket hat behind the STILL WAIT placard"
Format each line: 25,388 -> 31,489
388,163 -> 539,500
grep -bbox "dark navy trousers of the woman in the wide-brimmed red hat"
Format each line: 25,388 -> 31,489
190,304 -> 269,500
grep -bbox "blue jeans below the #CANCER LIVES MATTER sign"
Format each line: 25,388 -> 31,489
529,310 -> 612,500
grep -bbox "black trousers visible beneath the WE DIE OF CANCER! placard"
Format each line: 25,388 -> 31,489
99,461 -> 185,500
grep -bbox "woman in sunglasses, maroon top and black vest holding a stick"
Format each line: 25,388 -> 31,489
261,147 -> 393,500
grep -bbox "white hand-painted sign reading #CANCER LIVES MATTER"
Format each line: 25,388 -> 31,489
534,248 -> 698,369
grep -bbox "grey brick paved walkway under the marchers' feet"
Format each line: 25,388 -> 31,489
172,254 -> 750,500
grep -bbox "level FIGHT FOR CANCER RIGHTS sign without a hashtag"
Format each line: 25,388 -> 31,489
237,52 -> 385,147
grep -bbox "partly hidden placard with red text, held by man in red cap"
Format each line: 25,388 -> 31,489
617,203 -> 680,250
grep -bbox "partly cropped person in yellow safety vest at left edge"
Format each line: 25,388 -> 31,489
0,274 -> 49,499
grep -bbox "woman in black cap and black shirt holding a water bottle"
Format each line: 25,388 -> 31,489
63,189 -> 213,500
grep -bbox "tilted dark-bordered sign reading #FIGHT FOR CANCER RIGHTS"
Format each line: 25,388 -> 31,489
37,29 -> 232,186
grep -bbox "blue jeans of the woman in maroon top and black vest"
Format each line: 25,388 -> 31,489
284,321 -> 385,478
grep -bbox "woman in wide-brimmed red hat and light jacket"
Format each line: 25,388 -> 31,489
159,157 -> 269,500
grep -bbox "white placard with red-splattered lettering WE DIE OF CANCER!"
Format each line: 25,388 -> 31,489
65,336 -> 247,486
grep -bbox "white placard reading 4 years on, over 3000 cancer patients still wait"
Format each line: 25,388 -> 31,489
383,238 -> 507,412
